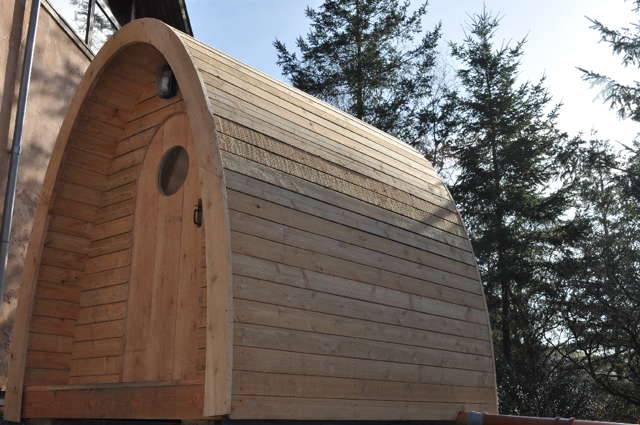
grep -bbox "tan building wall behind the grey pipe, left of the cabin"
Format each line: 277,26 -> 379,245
0,0 -> 90,388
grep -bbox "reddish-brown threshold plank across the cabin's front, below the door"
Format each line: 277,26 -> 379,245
24,384 -> 203,420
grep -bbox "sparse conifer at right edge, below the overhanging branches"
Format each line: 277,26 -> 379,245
560,140 -> 640,414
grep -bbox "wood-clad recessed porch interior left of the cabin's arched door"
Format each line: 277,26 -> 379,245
25,46 -> 192,387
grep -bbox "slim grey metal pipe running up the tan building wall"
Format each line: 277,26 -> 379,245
0,0 -> 40,305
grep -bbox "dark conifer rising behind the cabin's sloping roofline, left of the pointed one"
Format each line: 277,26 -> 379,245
274,0 -> 443,159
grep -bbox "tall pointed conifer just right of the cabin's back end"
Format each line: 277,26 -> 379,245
452,10 -> 584,415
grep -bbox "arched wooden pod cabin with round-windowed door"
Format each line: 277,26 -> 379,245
5,19 -> 497,421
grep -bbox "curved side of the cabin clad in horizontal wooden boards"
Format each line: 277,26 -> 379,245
185,37 -> 496,420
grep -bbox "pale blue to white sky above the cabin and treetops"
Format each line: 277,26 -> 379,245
187,0 -> 640,143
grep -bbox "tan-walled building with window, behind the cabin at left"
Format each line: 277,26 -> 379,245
0,0 -> 192,388
